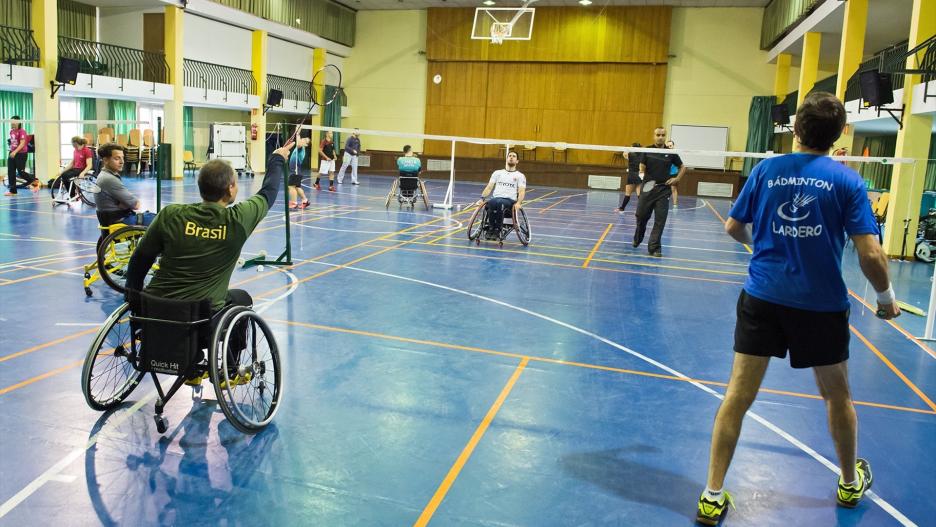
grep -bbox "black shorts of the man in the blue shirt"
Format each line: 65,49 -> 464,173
735,290 -> 851,368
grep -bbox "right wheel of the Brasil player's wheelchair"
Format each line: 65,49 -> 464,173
208,306 -> 283,434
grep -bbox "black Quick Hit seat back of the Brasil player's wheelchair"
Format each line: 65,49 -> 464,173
127,291 -> 211,375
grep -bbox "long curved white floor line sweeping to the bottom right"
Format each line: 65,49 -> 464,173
304,262 -> 917,527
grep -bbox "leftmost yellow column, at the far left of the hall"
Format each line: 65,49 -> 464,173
31,0 -> 62,181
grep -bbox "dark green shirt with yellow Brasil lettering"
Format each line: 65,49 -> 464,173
140,194 -> 270,310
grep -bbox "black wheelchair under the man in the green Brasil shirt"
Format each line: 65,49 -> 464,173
81,291 -> 283,434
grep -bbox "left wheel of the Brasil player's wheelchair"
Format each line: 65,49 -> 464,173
81,303 -> 143,411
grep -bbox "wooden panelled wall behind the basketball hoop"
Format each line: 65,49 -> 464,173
424,7 -> 671,164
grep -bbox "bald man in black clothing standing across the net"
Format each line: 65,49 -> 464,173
634,127 -> 686,257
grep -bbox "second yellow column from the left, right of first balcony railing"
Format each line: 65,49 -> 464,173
161,6 -> 185,178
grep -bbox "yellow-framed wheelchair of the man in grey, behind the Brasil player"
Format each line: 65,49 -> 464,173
83,223 -> 159,297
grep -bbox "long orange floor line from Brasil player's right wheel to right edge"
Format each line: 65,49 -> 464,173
268,320 -> 936,415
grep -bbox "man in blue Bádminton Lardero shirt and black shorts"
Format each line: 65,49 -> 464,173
696,92 -> 900,525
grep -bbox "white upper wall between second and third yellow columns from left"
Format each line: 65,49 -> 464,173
184,12 -> 252,70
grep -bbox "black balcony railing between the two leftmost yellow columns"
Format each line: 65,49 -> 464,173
58,36 -> 169,83
